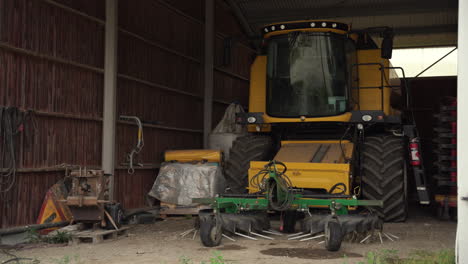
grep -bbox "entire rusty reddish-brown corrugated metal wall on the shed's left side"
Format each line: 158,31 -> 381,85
0,0 -> 254,227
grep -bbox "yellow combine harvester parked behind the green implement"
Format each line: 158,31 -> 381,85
226,21 -> 429,221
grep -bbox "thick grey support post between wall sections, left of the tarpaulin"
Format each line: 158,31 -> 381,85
102,0 -> 118,200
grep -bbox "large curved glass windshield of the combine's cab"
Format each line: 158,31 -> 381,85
267,32 -> 355,117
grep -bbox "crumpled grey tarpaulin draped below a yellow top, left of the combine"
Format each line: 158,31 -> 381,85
148,163 -> 222,205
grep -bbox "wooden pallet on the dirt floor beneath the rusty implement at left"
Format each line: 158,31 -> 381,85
70,227 -> 129,245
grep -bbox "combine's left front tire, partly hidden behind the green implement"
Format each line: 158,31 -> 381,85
224,135 -> 273,194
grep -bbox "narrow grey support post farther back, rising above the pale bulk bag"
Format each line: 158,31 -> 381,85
203,0 -> 214,148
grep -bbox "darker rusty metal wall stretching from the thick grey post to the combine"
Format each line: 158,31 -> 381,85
116,0 -> 254,207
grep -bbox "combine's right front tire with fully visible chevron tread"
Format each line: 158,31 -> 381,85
362,134 -> 408,222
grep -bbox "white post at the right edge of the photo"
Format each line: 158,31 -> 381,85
456,0 -> 468,263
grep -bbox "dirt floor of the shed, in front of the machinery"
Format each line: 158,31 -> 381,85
0,208 -> 456,264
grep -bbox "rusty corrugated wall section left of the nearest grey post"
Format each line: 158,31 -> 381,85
0,0 -> 104,227
